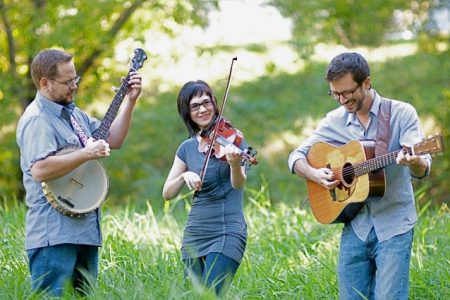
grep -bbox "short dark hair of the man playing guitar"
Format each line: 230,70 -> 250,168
325,52 -> 370,84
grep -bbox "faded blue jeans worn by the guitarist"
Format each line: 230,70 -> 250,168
338,224 -> 414,300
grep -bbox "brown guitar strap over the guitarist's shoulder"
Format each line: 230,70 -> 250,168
375,98 -> 392,157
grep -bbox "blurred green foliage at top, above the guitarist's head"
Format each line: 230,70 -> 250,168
268,0 -> 444,57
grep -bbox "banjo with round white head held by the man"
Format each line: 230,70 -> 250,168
42,48 -> 147,217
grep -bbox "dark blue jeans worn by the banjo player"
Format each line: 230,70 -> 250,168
27,244 -> 98,296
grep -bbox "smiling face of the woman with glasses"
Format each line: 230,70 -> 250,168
189,93 -> 215,130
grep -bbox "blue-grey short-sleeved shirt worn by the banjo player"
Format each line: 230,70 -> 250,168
16,92 -> 102,249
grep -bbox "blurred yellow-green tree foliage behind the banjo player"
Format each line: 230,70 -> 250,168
0,0 -> 217,202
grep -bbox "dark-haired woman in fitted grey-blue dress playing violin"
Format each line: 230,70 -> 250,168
163,80 -> 256,295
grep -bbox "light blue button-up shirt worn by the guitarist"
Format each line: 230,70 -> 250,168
288,92 -> 431,242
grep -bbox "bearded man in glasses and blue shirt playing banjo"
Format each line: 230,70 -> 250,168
17,49 -> 141,296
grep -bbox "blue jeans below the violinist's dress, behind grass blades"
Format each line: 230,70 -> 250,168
183,252 -> 239,295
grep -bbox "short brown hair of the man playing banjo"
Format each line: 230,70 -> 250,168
31,49 -> 72,89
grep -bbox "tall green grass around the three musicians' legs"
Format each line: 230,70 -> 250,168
0,190 -> 450,299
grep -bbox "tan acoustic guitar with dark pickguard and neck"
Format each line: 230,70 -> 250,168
306,135 -> 444,224
